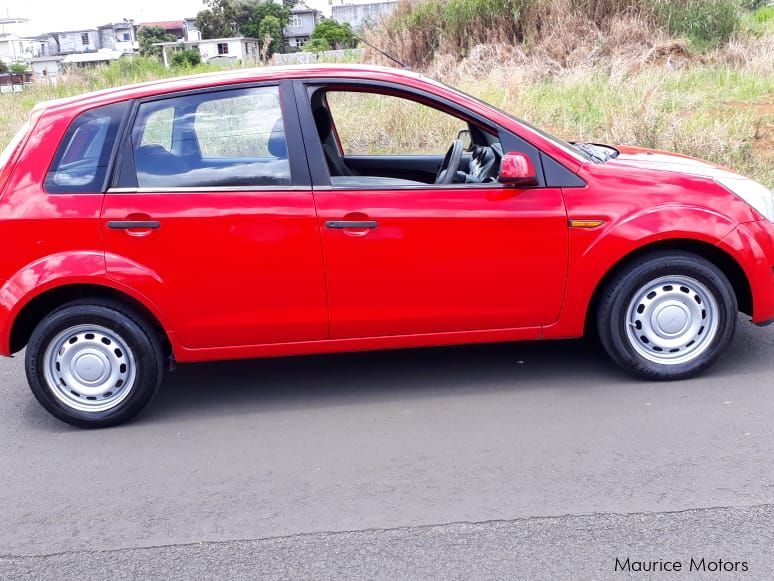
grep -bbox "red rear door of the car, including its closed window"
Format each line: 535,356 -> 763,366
101,79 -> 328,349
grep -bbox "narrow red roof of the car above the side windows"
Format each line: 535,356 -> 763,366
34,64 -> 431,111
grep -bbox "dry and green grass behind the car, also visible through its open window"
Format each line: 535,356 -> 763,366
0,27 -> 774,188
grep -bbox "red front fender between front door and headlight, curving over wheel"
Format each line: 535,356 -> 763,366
544,204 -> 738,338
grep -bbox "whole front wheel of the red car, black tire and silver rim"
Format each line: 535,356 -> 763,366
597,251 -> 737,380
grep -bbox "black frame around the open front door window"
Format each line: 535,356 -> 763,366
294,77 -> 569,191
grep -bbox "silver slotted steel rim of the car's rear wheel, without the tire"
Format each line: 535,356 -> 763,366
43,325 -> 136,412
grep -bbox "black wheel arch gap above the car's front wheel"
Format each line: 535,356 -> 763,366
584,238 -> 753,333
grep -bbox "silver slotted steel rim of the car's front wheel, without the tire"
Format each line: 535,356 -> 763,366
626,276 -> 719,365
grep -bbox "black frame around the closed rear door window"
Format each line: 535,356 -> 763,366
106,80 -> 312,194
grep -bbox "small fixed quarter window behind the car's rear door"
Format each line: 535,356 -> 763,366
45,103 -> 127,194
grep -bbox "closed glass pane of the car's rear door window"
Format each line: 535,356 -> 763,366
132,86 -> 291,188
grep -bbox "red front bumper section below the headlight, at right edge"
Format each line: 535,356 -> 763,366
718,220 -> 774,325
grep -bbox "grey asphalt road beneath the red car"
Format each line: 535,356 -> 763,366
0,320 -> 774,580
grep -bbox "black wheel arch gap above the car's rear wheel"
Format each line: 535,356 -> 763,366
9,283 -> 173,357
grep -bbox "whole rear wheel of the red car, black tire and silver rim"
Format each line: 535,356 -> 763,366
25,300 -> 164,428
